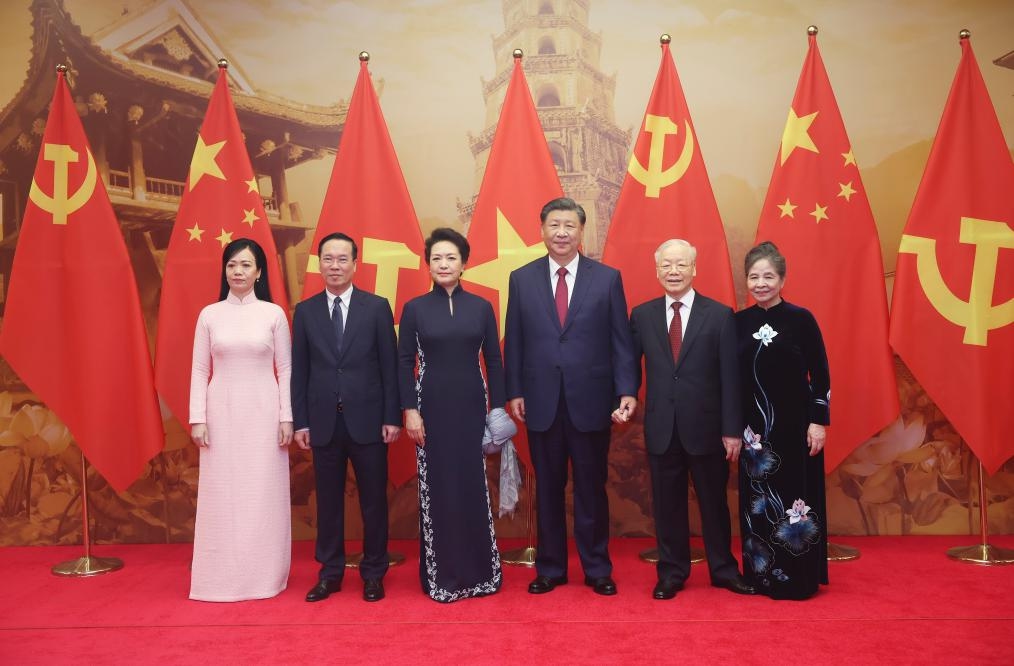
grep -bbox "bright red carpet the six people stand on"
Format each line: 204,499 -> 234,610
0,536 -> 1014,666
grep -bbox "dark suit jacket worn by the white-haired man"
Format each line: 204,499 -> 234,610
631,292 -> 743,455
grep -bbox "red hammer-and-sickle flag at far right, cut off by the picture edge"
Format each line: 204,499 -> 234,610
890,34 -> 1014,473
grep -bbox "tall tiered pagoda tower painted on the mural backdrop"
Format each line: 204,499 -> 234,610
458,0 -> 631,257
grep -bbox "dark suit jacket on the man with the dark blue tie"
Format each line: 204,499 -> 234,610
292,288 -> 402,446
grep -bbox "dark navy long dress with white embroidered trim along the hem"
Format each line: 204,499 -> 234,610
399,286 -> 506,602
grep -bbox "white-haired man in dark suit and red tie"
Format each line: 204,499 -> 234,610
631,239 -> 755,599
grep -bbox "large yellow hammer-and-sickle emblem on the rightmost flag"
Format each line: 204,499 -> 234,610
898,217 -> 1014,347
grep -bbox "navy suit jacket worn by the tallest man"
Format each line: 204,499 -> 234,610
504,255 -> 637,432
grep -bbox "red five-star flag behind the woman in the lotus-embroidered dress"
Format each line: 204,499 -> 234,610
756,34 -> 898,470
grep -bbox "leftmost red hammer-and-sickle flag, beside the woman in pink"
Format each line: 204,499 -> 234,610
0,72 -> 163,491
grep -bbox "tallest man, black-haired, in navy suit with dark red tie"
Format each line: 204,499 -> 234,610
504,198 -> 637,595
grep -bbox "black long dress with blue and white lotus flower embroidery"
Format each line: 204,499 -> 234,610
736,301 -> 831,599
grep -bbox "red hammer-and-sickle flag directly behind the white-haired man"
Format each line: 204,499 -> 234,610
602,35 -> 736,308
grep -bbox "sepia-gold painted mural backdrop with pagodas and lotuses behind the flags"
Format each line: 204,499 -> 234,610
0,0 -> 1014,545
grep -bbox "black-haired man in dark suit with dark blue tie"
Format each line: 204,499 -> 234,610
292,233 -> 402,601
